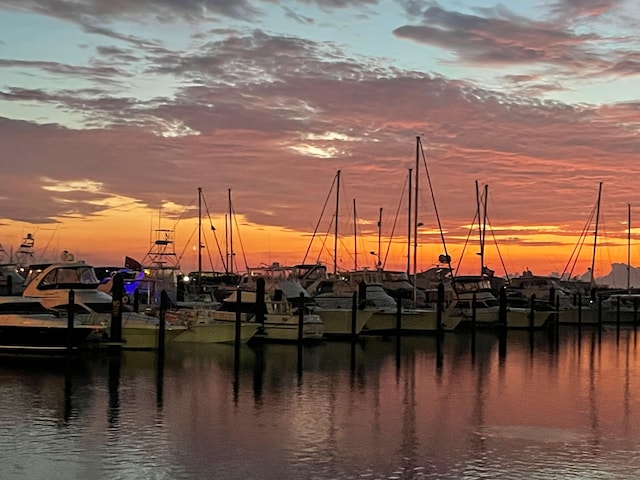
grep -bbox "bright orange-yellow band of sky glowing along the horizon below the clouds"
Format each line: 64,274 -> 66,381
0,212 -> 634,276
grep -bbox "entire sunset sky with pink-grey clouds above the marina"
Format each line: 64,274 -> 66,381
0,0 -> 640,276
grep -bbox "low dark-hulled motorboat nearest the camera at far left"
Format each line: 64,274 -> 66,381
0,296 -> 105,353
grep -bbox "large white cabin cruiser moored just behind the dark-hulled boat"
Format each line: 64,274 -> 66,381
22,261 -> 186,349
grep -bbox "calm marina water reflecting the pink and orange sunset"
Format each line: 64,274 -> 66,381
0,327 -> 640,480
